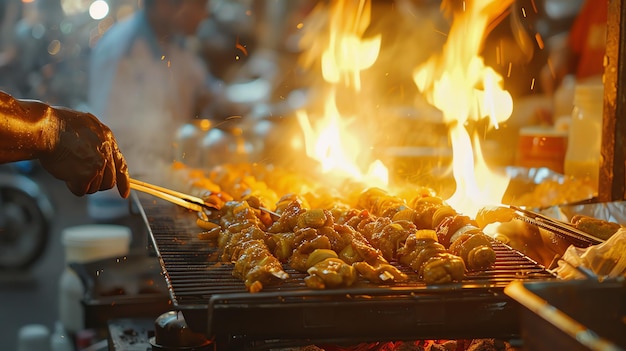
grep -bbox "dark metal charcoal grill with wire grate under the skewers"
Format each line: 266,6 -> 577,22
137,194 -> 556,350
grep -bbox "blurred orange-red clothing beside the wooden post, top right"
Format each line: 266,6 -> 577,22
541,0 -> 608,94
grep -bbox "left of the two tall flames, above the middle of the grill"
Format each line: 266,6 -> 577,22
296,0 -> 382,187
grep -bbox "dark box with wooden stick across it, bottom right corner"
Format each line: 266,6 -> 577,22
505,279 -> 626,351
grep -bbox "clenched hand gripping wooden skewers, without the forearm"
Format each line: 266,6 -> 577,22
39,107 -> 130,198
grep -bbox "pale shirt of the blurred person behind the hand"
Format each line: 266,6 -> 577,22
88,10 -> 209,181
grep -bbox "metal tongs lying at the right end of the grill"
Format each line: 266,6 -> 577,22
510,205 -> 604,246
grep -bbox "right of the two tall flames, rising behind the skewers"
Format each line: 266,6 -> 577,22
413,0 -> 513,215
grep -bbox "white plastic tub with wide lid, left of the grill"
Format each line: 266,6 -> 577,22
59,224 -> 131,334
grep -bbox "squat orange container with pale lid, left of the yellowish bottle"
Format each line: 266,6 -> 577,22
515,126 -> 568,174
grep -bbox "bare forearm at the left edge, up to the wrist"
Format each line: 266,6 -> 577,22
0,91 -> 61,163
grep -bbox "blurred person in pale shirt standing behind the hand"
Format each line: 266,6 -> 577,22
88,0 -> 214,219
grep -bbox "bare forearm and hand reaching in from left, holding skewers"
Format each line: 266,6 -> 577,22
0,91 -> 130,198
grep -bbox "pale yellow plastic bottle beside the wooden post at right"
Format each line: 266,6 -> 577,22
564,81 -> 604,191
